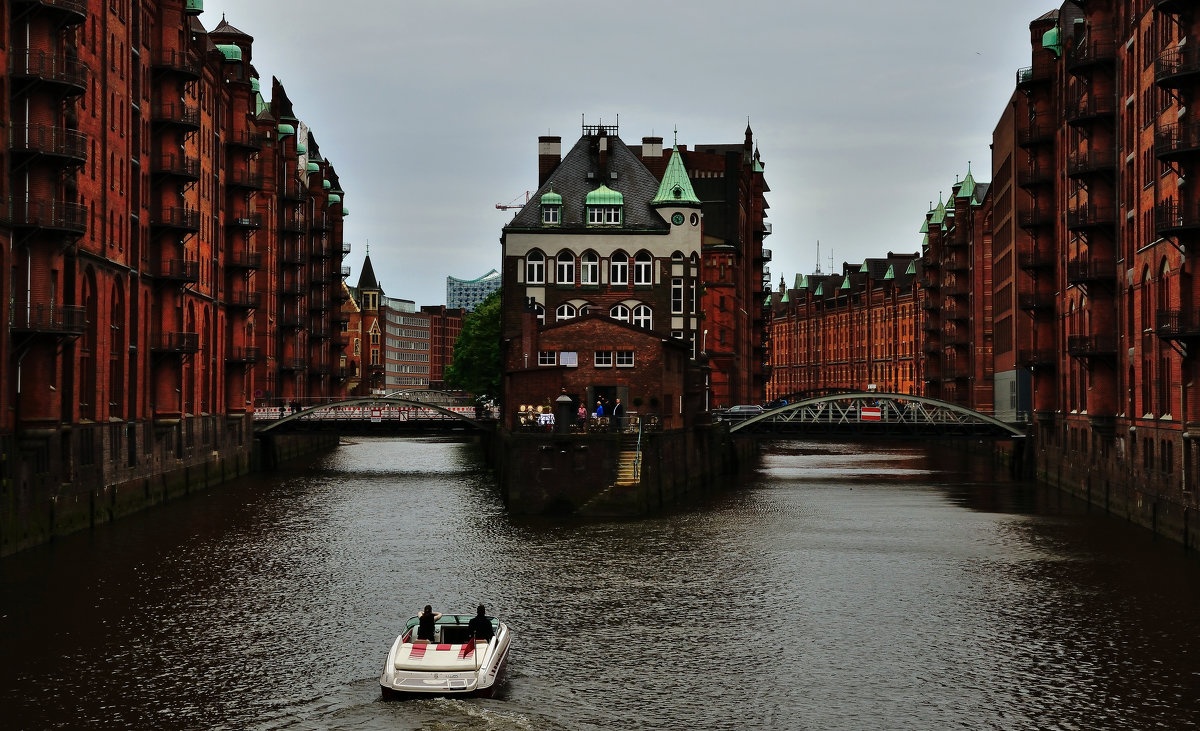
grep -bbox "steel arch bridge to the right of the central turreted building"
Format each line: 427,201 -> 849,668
730,391 -> 1025,437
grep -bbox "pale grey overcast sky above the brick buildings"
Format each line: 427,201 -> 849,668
200,0 -> 1057,305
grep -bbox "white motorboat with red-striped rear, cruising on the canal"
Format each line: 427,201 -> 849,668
379,615 -> 511,697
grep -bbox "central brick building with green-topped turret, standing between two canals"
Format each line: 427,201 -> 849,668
502,125 -> 768,425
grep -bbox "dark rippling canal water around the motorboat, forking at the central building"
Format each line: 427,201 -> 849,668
0,439 -> 1200,731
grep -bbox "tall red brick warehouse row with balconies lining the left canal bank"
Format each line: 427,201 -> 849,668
0,0 -> 346,551
